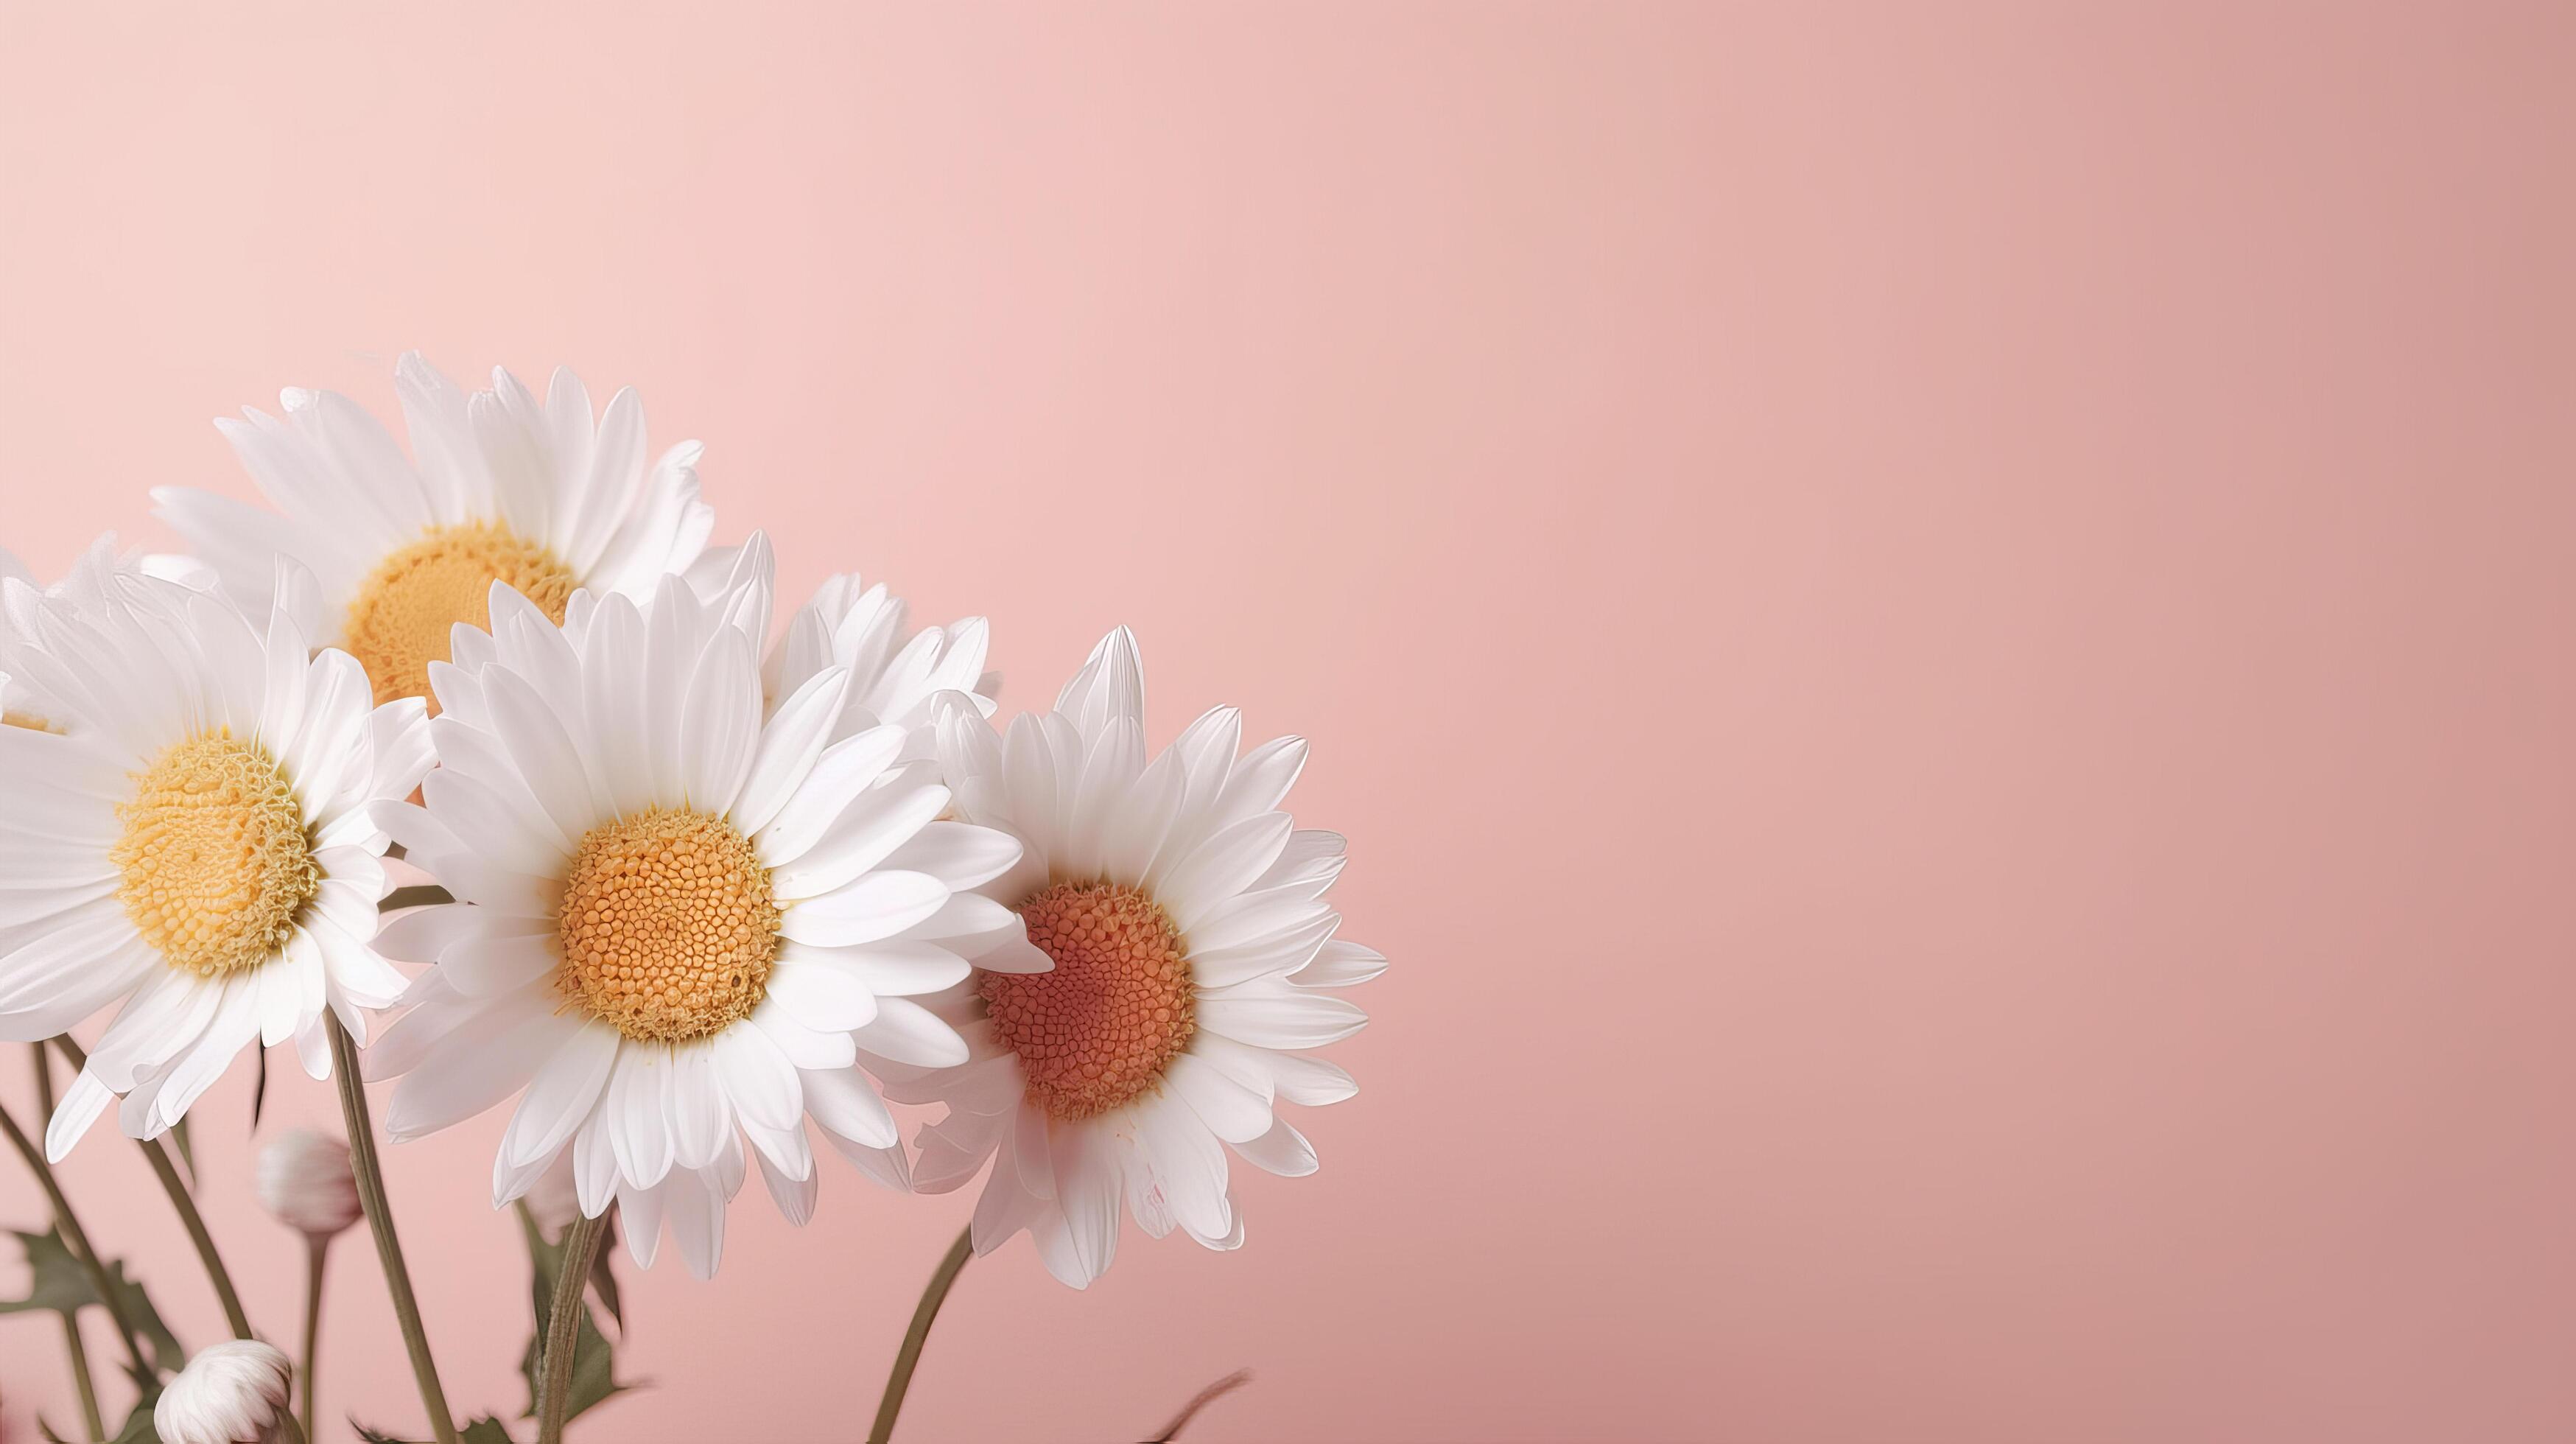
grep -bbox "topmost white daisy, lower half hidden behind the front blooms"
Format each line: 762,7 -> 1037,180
152,354 -> 716,701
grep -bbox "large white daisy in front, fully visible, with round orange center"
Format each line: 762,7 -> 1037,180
368,552 -> 1020,1277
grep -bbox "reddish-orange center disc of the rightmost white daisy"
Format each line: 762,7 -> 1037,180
976,882 -> 1198,1122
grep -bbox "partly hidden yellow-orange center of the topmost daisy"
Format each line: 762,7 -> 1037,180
343,521 -> 580,712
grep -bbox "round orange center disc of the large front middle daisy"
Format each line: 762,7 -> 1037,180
554,813 -> 778,1042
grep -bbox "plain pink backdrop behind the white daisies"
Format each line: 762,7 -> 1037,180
0,3 -> 2576,1444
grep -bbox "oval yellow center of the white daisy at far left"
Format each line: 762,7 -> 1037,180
108,732 -> 322,978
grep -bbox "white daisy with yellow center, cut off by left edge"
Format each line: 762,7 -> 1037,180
0,572 -> 430,1158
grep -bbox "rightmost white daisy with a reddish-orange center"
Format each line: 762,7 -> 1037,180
881,629 -> 1386,1287
